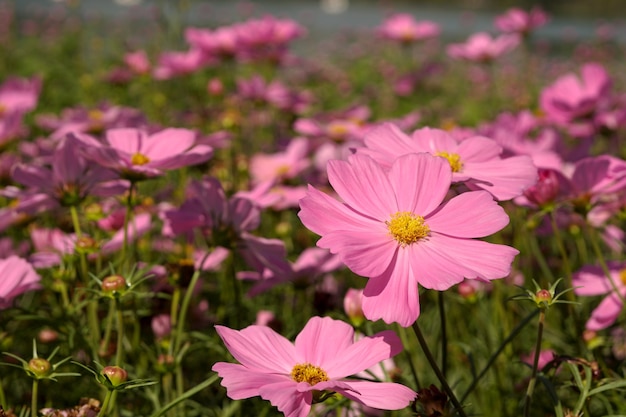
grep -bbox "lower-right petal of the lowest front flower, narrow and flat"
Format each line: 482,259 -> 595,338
338,381 -> 417,410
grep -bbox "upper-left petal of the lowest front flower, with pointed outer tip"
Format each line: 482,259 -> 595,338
215,325 -> 297,375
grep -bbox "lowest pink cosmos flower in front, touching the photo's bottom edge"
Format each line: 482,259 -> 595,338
212,317 -> 416,417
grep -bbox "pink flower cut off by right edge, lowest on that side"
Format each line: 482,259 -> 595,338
572,261 -> 626,331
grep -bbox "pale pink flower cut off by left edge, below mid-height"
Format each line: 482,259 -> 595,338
0,255 -> 41,310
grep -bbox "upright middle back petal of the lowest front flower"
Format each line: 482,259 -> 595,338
294,317 -> 354,366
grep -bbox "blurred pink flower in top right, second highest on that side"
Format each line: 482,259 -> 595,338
447,32 -> 520,62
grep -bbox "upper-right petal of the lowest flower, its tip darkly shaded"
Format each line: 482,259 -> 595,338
322,330 -> 402,379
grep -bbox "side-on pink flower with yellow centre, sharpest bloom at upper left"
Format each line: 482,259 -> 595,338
77,128 -> 213,181
